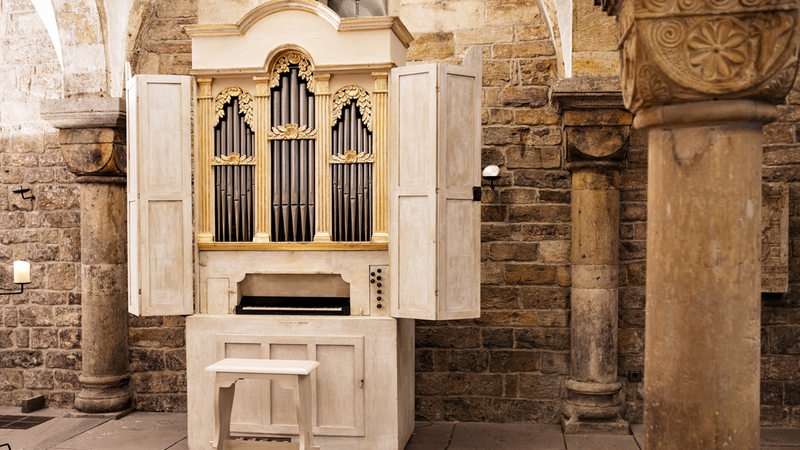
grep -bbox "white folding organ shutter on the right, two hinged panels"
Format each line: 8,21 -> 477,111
389,49 -> 481,320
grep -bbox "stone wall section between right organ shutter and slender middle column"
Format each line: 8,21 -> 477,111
404,0 -> 570,423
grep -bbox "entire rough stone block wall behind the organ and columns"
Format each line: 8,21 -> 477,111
0,0 -> 800,426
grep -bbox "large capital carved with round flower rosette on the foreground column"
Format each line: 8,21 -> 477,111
603,0 -> 800,112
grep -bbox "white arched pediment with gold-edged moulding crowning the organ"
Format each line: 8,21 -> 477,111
186,0 -> 413,71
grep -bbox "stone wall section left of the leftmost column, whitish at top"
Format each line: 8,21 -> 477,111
0,0 -> 76,407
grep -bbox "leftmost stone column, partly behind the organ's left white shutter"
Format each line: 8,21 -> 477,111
42,97 -> 131,413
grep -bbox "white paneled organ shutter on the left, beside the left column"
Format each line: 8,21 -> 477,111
127,75 -> 194,316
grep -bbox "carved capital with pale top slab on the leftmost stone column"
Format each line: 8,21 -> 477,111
41,97 -> 127,178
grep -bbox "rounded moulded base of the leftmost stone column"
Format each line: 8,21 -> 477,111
75,375 -> 131,414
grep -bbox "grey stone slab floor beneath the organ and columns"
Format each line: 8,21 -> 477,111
0,408 -> 800,450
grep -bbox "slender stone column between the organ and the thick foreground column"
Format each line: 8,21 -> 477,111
553,78 -> 631,433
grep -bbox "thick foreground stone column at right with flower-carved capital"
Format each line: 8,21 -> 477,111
604,0 -> 799,450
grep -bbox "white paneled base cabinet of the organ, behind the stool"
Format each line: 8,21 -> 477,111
186,314 -> 414,450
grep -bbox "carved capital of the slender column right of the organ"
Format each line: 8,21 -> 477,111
552,77 -> 632,170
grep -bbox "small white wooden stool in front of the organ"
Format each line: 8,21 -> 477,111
206,358 -> 319,450
